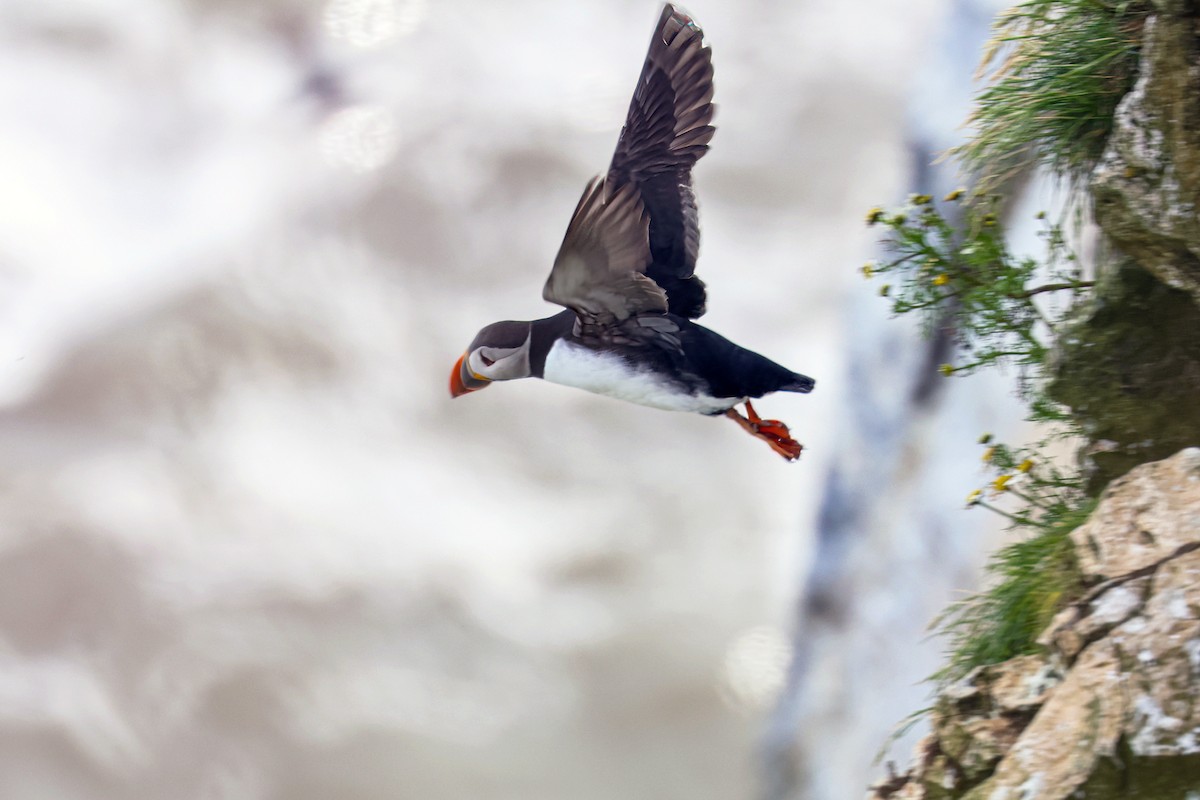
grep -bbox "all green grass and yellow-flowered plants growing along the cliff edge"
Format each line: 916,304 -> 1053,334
863,0 -> 1150,684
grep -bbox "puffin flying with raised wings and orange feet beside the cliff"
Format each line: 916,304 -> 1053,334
450,5 -> 814,461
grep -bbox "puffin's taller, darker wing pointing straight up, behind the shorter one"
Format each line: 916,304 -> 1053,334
607,5 -> 715,318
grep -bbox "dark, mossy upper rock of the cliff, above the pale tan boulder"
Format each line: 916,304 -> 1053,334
1050,0 -> 1200,491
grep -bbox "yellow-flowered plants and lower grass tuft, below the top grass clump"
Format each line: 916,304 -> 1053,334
863,192 -> 1094,682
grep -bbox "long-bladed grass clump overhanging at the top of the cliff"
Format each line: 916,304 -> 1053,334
955,0 -> 1150,191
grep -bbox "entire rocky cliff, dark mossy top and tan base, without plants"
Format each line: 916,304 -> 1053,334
871,0 -> 1200,800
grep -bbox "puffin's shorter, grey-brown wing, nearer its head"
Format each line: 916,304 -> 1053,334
541,175 -> 667,329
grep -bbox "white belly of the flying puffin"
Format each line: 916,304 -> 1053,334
542,339 -> 745,414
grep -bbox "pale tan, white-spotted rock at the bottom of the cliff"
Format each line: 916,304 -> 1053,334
871,447 -> 1200,800
